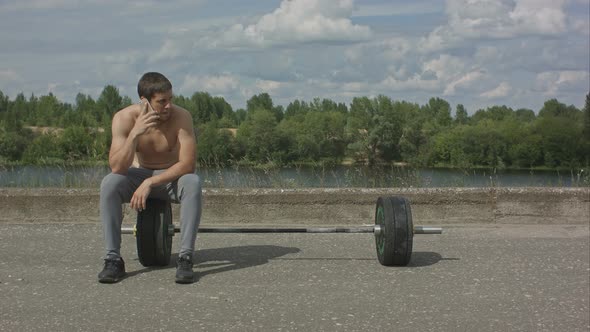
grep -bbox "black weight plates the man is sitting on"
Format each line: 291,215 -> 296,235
136,199 -> 172,266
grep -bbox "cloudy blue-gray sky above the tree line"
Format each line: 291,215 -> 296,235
0,0 -> 590,114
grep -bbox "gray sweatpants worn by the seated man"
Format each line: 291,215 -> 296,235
100,167 -> 201,258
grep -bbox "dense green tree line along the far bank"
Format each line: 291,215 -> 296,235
0,85 -> 590,169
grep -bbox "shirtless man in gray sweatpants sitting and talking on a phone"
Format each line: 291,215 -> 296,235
98,72 -> 201,283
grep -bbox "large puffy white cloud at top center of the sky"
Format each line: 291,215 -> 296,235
208,0 -> 371,47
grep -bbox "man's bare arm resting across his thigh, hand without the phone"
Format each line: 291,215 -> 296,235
130,112 -> 197,210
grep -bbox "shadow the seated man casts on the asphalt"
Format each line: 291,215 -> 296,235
125,245 -> 301,279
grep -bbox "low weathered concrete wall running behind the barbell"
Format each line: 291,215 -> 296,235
0,188 -> 590,225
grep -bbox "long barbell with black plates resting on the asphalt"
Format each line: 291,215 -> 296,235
121,196 -> 442,266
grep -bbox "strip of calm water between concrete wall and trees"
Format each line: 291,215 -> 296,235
0,166 -> 590,188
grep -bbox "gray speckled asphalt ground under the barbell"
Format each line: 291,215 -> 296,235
0,223 -> 590,331
